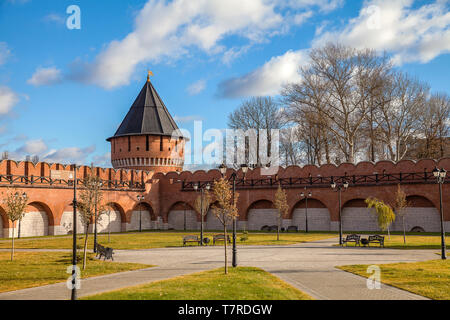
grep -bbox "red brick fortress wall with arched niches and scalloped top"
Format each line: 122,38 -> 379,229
0,157 -> 450,227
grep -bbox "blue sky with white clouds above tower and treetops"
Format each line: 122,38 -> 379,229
0,0 -> 450,166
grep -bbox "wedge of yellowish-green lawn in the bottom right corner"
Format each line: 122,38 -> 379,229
338,260 -> 450,300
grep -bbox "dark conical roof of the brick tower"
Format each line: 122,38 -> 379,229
107,80 -> 181,141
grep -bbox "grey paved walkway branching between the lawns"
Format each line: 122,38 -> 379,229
0,239 -> 437,300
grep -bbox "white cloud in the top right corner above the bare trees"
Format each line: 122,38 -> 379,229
313,0 -> 450,64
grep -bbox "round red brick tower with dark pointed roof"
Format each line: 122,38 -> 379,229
106,72 -> 185,172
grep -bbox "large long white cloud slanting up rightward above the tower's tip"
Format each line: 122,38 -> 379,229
73,0 -> 342,89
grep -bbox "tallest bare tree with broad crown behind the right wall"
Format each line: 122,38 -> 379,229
283,44 -> 390,162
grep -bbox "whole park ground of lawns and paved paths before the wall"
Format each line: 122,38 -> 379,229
0,232 -> 450,300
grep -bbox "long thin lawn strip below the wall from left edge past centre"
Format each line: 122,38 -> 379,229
0,231 -> 336,250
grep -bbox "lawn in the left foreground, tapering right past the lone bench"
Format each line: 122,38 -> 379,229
0,252 -> 151,292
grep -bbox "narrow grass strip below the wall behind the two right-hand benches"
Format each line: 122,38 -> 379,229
344,233 -> 450,249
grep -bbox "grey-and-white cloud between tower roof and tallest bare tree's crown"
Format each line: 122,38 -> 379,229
218,50 -> 307,98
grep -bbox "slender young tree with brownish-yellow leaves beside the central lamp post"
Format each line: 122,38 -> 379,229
212,178 -> 239,274
